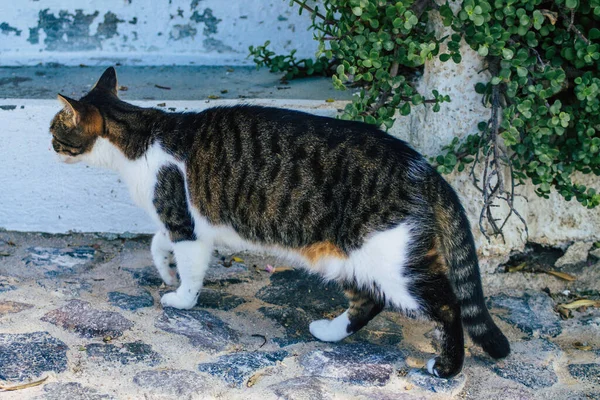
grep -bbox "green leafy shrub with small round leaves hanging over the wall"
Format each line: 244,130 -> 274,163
250,0 -> 600,234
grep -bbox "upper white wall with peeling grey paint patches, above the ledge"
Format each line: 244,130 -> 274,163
0,0 -> 316,65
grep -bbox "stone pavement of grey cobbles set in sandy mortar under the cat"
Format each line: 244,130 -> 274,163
0,232 -> 600,400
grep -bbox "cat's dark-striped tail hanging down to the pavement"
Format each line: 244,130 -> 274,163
434,177 -> 510,358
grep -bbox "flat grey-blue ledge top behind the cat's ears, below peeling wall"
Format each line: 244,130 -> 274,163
0,65 -> 352,101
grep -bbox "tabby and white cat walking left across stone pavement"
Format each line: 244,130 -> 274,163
50,67 -> 510,378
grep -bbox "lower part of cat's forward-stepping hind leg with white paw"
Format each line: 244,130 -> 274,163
309,288 -> 384,342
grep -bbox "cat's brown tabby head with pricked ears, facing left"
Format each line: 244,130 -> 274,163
50,67 -> 117,164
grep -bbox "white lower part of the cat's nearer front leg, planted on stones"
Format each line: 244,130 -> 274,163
160,240 -> 212,309
